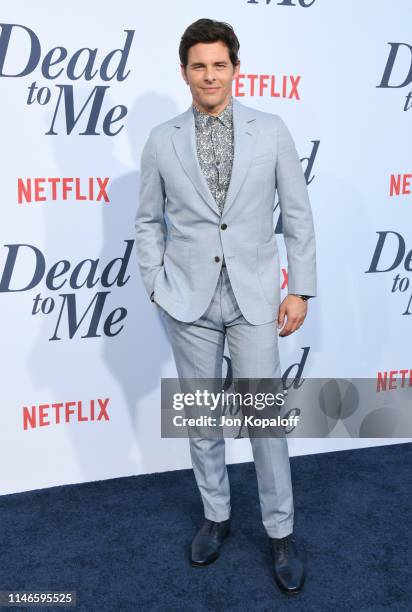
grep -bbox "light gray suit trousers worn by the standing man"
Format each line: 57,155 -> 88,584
154,266 -> 294,538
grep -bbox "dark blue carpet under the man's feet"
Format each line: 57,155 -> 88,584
0,444 -> 412,612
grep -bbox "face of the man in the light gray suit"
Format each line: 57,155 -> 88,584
181,40 -> 240,114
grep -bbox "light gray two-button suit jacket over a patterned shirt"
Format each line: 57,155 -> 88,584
135,98 -> 316,325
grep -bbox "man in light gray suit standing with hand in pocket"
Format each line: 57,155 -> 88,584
135,19 -> 316,593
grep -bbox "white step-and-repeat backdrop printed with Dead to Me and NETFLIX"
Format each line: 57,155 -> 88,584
0,0 -> 412,493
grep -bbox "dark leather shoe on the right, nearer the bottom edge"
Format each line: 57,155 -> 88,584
269,533 -> 306,595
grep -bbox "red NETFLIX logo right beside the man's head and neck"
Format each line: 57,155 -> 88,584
233,74 -> 301,100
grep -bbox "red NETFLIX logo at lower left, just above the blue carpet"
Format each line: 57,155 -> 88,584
22,397 -> 110,430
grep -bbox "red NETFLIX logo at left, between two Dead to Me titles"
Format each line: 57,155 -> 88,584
17,176 -> 110,204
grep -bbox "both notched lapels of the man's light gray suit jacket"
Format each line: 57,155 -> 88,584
172,98 -> 257,217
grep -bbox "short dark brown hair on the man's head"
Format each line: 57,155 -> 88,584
179,19 -> 240,68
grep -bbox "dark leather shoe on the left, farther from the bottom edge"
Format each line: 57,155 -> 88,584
190,519 -> 230,567
